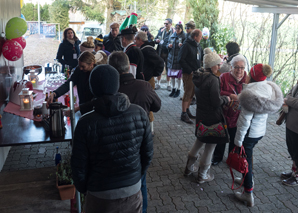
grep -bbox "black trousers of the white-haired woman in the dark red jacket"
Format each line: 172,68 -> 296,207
212,127 -> 237,162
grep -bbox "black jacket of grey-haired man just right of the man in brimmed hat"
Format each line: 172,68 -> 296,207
140,41 -> 164,81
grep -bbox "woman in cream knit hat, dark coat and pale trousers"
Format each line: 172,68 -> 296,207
184,53 -> 230,183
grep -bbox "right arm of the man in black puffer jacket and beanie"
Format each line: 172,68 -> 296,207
140,113 -> 153,176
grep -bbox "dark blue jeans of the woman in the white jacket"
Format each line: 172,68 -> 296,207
243,136 -> 263,192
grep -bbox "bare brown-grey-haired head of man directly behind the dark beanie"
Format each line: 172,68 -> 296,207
108,51 -> 130,75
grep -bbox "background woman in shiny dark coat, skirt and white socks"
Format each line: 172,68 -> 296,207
167,22 -> 186,98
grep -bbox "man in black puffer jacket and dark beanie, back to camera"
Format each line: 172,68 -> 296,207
71,65 -> 153,213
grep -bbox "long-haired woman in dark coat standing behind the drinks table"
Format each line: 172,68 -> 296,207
56,28 -> 81,71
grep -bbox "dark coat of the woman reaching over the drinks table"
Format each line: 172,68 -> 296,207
54,67 -> 93,114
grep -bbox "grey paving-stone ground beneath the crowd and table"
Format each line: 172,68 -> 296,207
3,85 -> 298,213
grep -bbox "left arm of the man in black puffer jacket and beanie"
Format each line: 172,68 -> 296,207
71,119 -> 89,193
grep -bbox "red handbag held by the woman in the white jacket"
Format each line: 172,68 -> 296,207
226,146 -> 248,190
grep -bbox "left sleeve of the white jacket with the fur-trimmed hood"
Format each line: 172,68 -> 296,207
234,108 -> 254,147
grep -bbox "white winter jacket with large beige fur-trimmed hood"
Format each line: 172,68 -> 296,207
234,81 -> 283,147
